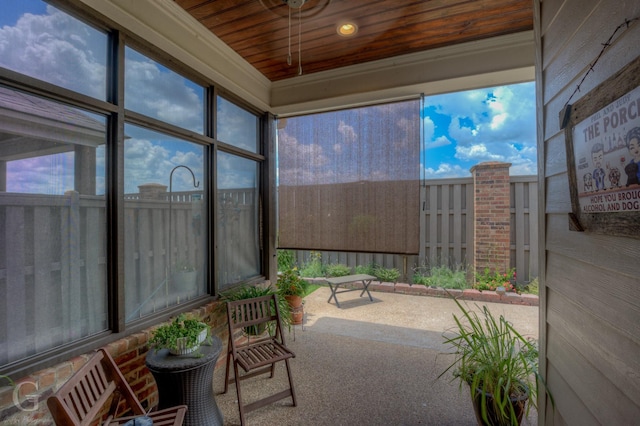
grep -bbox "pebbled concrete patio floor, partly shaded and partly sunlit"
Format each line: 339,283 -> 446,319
214,287 -> 538,426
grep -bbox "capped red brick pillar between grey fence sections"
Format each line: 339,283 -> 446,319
471,161 -> 511,278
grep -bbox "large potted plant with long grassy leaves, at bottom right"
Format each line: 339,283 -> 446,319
440,299 -> 553,425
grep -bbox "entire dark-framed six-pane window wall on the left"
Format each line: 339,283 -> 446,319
0,0 -> 265,374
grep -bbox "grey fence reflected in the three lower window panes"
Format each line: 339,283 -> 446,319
0,186 -> 260,365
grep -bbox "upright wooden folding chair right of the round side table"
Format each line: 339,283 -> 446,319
224,294 -> 297,425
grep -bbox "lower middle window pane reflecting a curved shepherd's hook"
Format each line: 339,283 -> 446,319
124,125 -> 207,321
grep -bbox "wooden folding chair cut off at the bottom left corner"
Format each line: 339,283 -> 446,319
47,349 -> 187,426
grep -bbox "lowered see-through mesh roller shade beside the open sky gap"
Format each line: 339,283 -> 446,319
278,99 -> 420,254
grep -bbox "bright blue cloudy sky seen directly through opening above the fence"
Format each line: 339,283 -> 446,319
422,82 -> 537,179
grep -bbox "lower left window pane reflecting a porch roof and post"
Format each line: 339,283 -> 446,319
0,87 -> 107,365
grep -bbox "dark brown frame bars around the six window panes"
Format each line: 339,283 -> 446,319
0,0 -> 275,377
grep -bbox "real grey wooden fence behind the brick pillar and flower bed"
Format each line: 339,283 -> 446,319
288,176 -> 538,283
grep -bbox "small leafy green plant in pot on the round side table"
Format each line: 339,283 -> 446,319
149,314 -> 209,355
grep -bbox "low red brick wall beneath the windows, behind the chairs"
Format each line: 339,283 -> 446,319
0,302 -> 228,426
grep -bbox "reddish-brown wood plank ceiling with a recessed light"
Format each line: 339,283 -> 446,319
174,0 -> 533,81
